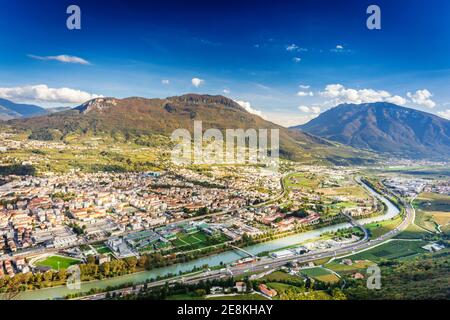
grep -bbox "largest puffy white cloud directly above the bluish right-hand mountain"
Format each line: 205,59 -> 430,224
320,84 -> 407,105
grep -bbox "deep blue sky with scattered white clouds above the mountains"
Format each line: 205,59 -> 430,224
0,0 -> 450,125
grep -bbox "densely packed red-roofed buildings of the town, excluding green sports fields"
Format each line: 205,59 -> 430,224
0,168 -> 280,270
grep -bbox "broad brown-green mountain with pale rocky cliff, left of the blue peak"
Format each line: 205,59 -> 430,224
7,94 -> 371,164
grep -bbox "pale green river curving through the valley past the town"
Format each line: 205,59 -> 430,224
11,180 -> 399,300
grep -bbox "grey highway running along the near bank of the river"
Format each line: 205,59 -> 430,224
81,179 -> 415,300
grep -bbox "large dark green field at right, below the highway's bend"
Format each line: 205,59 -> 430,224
347,240 -> 427,262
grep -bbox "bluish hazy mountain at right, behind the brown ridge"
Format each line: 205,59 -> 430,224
292,102 -> 450,160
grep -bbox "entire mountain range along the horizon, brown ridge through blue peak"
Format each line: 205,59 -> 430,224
4,94 -> 450,164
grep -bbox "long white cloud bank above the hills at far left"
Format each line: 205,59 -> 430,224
0,84 -> 102,104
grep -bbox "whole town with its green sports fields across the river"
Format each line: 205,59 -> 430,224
0,166 -> 382,277
